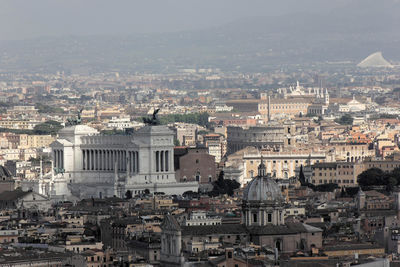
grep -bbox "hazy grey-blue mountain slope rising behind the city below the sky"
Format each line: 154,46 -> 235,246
0,0 -> 400,72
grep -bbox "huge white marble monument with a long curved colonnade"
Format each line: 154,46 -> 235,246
50,124 -> 198,199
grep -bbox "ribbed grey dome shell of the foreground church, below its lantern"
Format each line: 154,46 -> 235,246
243,176 -> 284,202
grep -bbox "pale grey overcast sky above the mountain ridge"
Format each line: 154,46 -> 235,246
0,0 -> 357,40
